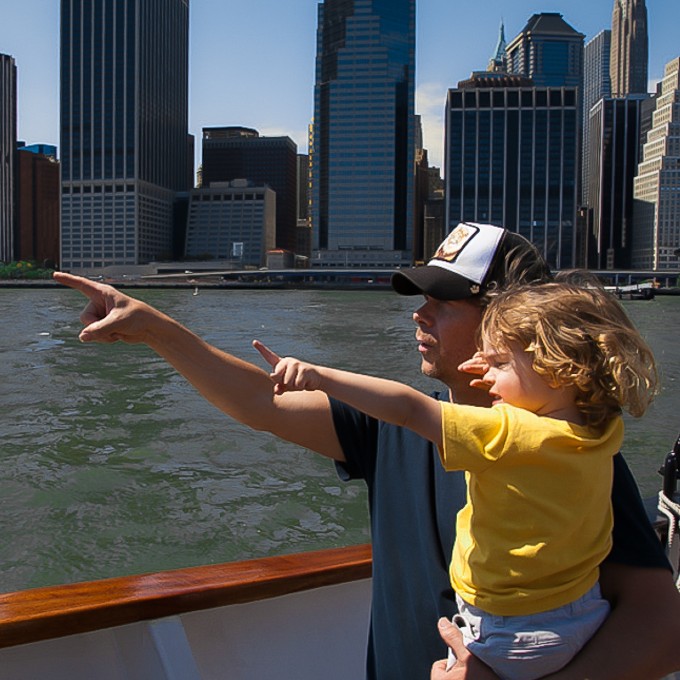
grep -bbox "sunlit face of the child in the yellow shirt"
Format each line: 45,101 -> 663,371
482,338 -> 574,417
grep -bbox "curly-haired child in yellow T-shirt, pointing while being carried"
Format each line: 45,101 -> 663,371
254,283 -> 657,680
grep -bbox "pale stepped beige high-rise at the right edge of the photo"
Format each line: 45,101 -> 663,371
632,58 -> 680,271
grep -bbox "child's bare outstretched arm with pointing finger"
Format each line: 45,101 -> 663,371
253,340 -> 442,446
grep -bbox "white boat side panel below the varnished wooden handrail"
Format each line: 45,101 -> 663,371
0,580 -> 371,680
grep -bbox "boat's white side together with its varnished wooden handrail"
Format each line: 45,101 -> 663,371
0,546 -> 371,680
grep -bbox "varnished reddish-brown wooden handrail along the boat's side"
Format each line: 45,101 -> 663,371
0,545 -> 371,647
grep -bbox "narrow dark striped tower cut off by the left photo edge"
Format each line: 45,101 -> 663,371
0,54 -> 17,262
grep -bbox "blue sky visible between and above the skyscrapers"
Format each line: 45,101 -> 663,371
0,0 -> 680,170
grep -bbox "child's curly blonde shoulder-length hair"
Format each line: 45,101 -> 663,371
480,282 -> 658,427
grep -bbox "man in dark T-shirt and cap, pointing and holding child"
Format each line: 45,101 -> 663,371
55,225 -> 680,680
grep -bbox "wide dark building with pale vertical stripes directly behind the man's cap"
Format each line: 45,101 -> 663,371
445,72 -> 581,268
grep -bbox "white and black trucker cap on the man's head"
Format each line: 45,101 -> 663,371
391,222 -> 540,300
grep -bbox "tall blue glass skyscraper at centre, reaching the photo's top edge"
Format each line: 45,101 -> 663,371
310,0 -> 415,266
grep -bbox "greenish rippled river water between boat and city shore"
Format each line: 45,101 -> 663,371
0,289 -> 680,591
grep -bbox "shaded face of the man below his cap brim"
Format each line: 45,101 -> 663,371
413,295 -> 486,401
